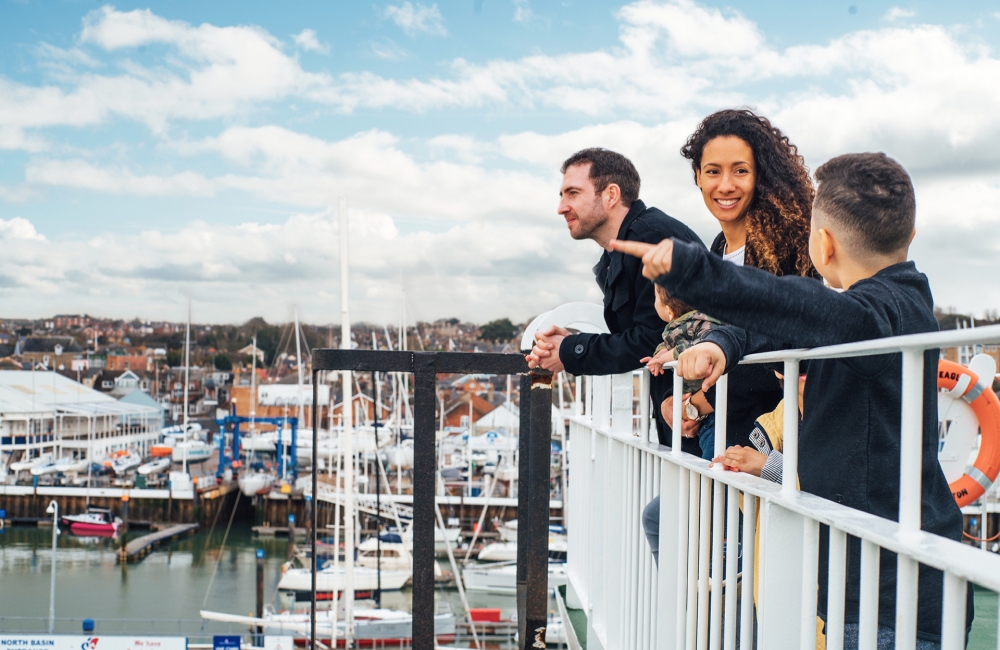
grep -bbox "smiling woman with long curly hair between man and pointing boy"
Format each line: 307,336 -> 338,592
642,109 -> 819,562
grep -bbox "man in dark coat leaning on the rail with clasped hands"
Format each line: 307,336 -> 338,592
527,148 -> 704,448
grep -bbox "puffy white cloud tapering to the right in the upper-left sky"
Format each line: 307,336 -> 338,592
0,6 -> 330,132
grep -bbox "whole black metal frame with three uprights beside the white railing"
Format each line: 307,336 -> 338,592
311,349 -> 552,650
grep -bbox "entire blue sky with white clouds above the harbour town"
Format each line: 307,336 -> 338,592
0,0 -> 1000,322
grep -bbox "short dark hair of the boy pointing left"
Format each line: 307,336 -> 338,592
813,153 -> 917,255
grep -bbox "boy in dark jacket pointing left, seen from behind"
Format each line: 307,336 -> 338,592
611,153 -> 973,648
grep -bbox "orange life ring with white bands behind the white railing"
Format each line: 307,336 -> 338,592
938,359 -> 1000,507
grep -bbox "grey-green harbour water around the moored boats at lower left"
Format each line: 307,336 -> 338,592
0,522 -> 516,648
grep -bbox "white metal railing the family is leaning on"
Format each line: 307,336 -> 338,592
567,326 -> 1000,650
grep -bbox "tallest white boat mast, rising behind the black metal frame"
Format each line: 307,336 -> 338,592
338,197 -> 354,647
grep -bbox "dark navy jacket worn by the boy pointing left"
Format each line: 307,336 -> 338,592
656,242 -> 974,640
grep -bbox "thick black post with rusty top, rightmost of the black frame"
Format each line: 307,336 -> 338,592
517,371 -> 552,650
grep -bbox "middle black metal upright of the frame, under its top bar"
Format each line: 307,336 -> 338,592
413,352 -> 437,650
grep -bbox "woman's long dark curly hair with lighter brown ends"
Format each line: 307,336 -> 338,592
681,108 -> 816,275
